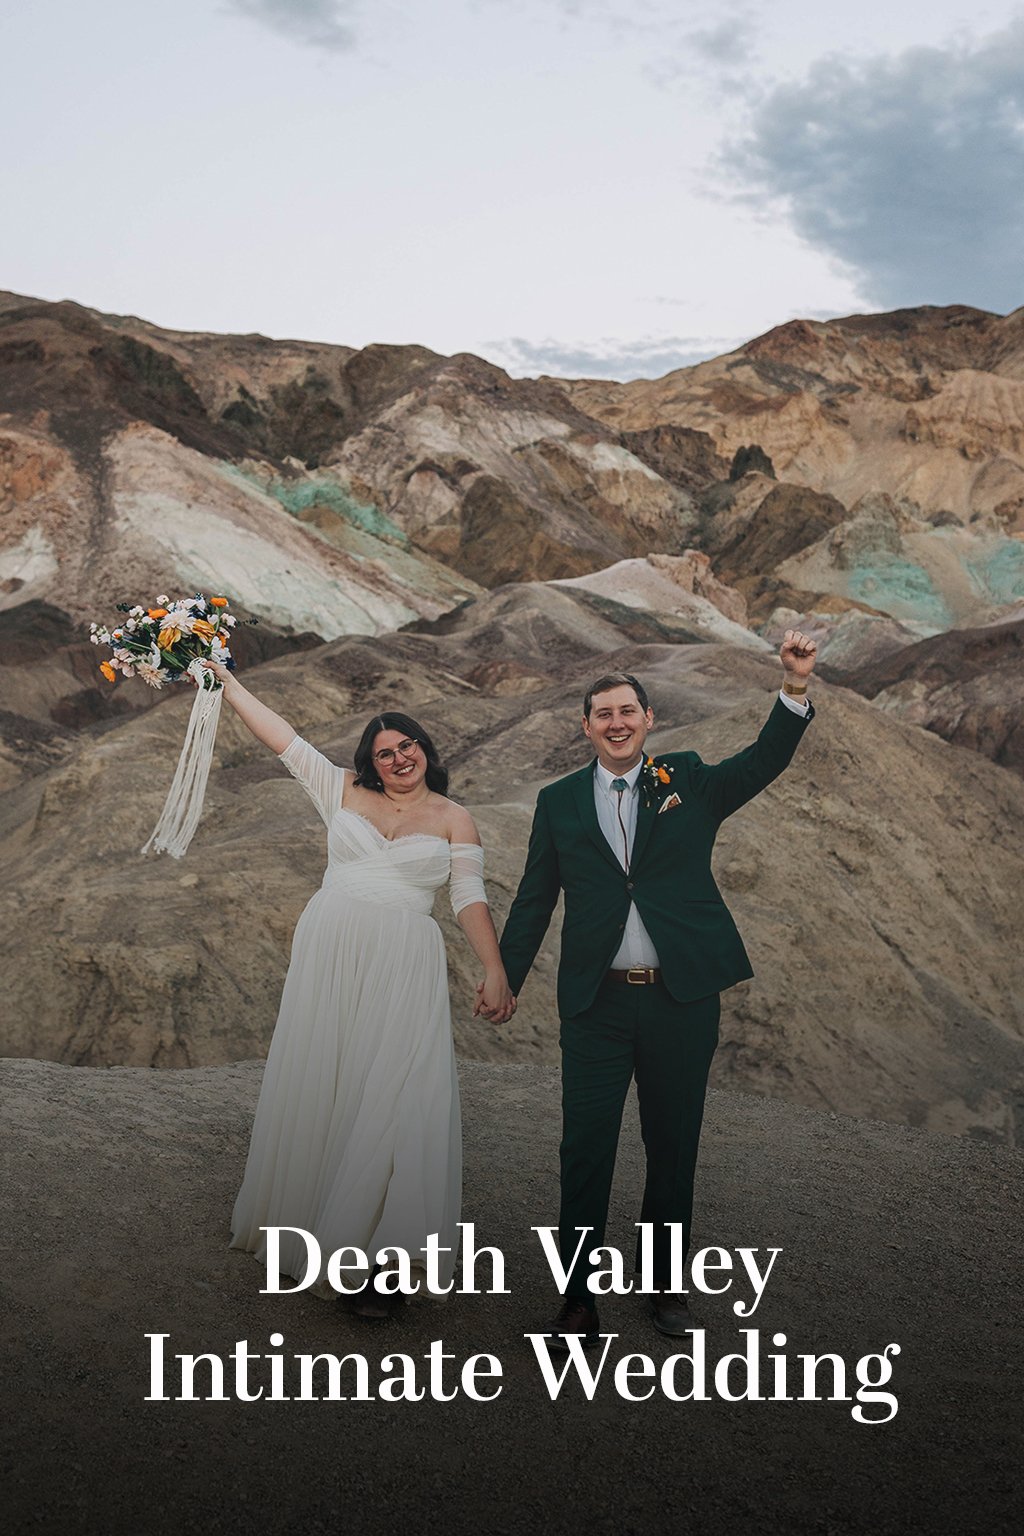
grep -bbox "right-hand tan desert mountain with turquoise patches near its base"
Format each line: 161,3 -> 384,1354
563,307 -> 1024,637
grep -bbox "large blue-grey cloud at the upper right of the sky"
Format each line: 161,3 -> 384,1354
722,18 -> 1024,312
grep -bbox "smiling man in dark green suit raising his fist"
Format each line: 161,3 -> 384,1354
500,630 -> 815,1349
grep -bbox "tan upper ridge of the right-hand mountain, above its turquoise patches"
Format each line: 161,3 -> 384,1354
565,306 -> 1024,531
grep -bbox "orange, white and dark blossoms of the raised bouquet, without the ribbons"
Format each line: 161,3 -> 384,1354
89,593 -> 256,688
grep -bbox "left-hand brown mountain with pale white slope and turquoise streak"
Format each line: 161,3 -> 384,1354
0,295 -> 700,620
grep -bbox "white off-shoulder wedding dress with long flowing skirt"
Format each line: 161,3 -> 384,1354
232,737 -> 484,1298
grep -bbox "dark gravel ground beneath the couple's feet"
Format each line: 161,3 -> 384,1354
0,1061 -> 1024,1536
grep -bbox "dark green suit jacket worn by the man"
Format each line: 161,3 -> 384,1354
500,699 -> 814,1018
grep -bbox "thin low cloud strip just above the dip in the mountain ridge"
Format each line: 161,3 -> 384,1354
487,336 -> 742,379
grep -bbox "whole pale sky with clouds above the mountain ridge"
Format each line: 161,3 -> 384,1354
0,0 -> 1024,378
